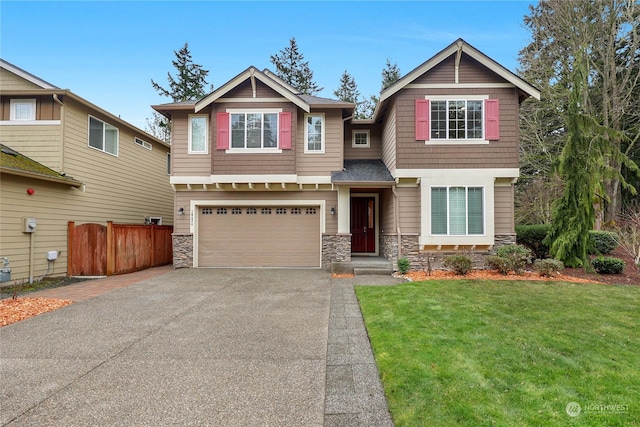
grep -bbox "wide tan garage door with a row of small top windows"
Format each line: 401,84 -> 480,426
198,206 -> 320,267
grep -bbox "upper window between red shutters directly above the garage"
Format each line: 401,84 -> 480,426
230,112 -> 278,149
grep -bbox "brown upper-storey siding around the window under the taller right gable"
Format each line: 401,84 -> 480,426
396,88 -> 519,169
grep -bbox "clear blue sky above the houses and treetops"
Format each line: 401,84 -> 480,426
0,0 -> 537,129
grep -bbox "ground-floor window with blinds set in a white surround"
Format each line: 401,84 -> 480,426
431,186 -> 484,236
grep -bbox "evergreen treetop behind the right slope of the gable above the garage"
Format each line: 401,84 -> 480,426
271,38 -> 323,95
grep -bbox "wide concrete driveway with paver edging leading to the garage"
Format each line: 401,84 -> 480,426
0,267 -> 397,426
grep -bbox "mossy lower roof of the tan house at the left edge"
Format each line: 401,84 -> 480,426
0,144 -> 82,188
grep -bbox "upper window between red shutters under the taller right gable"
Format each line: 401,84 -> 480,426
431,99 -> 483,139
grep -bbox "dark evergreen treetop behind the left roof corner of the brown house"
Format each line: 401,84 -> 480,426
151,43 -> 213,102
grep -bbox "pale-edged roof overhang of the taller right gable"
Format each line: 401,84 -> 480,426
374,39 -> 540,118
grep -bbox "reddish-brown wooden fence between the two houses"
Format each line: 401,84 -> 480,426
67,221 -> 173,276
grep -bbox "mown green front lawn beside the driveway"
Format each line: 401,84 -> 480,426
356,280 -> 640,426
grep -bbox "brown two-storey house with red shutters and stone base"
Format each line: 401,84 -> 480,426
153,40 -> 540,267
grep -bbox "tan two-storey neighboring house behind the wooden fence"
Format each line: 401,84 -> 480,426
0,60 -> 174,280
